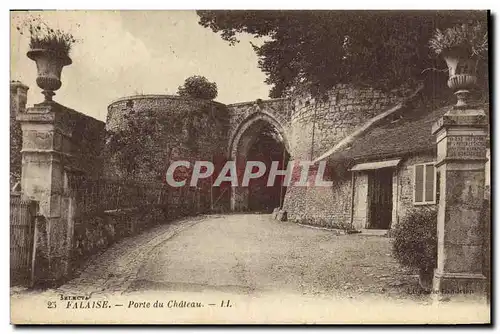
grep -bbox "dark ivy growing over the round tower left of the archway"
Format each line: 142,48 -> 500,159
106,101 -> 227,181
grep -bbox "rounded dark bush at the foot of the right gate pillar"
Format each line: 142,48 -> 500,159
392,208 -> 437,271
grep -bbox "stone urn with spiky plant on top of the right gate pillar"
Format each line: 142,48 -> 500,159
429,23 -> 488,108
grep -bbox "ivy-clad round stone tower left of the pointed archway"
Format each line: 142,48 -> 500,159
104,95 -> 229,182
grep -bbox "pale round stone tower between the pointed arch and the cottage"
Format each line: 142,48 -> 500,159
284,84 -> 411,226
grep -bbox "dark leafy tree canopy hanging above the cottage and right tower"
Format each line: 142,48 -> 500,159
197,11 -> 487,97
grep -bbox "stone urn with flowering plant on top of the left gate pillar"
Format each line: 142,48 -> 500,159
17,18 -> 76,101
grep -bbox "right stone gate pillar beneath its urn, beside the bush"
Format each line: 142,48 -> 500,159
432,107 -> 487,294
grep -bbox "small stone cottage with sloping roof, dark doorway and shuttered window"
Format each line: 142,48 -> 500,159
310,98 -> 490,229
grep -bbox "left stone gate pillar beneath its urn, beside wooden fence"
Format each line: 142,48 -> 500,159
17,103 -> 73,284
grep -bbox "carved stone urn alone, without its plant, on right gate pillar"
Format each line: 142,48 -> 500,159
443,48 -> 477,107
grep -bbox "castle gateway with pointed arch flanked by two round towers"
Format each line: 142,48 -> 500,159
104,84 -> 415,217
